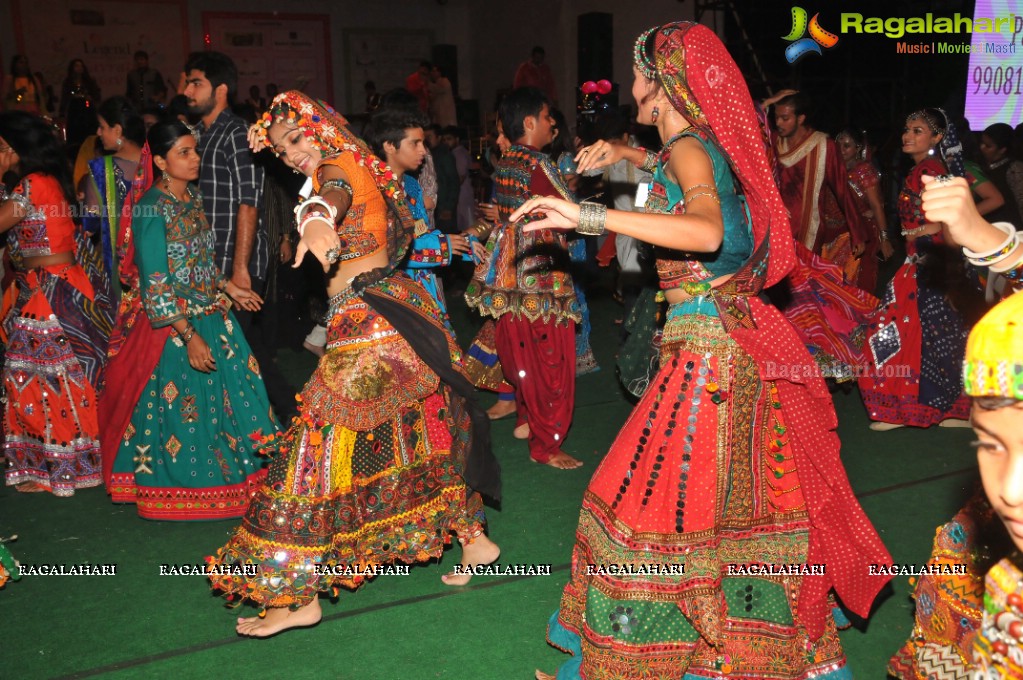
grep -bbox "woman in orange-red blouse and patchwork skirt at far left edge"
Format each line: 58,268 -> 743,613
0,111 -> 114,496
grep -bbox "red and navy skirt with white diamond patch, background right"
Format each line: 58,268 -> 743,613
859,237 -> 970,427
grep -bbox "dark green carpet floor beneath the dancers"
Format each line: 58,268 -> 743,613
0,284 -> 977,680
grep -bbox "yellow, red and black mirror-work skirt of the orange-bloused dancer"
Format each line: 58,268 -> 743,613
209,273 -> 484,606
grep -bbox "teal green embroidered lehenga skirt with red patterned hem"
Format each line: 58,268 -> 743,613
106,304 -> 277,520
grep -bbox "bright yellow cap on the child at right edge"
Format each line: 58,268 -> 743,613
963,292 -> 1023,400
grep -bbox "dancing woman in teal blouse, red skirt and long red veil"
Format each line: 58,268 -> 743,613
513,22 -> 890,680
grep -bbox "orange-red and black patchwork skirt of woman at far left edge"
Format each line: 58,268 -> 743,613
3,264 -> 110,496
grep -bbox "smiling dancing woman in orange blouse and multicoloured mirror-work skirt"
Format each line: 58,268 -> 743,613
203,91 -> 500,637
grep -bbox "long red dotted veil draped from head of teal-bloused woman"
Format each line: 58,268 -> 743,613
635,21 -> 891,639
